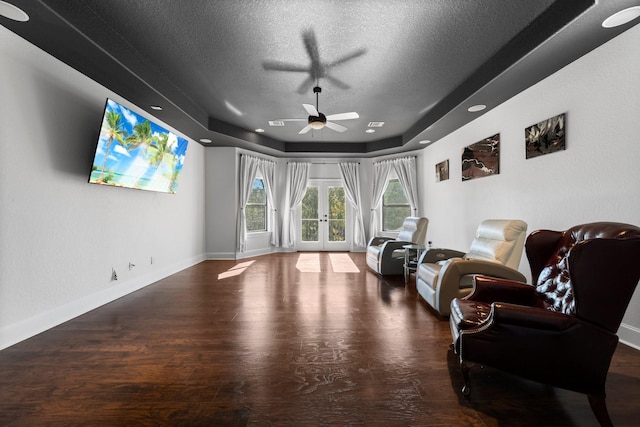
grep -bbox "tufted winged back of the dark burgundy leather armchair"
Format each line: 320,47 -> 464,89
526,222 -> 640,332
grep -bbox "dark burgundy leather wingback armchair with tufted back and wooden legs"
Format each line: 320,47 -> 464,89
449,222 -> 640,426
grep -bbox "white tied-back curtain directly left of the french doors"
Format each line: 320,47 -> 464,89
282,162 -> 311,248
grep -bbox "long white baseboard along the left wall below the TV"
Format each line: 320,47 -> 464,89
0,255 -> 205,350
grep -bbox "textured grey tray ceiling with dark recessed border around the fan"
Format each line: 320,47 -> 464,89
0,0 -> 639,156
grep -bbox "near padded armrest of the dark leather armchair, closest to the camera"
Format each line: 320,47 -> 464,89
490,302 -> 577,331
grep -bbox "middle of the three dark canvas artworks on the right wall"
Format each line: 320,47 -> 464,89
462,133 -> 500,181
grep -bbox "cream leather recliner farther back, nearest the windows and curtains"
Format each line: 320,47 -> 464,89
367,216 -> 429,276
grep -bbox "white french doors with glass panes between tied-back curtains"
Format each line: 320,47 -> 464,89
296,180 -> 350,251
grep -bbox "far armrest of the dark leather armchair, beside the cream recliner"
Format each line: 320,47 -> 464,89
465,276 -> 537,306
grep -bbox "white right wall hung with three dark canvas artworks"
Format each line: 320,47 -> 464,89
421,26 -> 640,347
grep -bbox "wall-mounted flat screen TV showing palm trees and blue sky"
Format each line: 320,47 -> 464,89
89,99 -> 188,193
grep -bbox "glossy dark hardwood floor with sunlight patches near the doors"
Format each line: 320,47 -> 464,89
0,253 -> 640,427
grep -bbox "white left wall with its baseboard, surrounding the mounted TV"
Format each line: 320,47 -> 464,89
0,27 -> 205,348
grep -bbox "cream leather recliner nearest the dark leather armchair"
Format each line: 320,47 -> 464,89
416,219 -> 527,316
